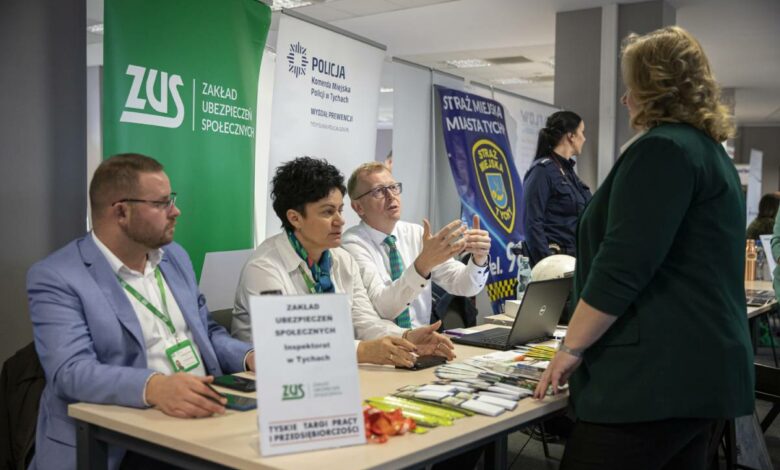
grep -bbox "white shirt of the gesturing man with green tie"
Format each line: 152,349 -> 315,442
342,221 -> 488,328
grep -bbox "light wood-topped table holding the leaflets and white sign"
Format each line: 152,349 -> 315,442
68,345 -> 567,470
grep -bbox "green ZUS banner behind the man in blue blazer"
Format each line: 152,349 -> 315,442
103,0 -> 271,275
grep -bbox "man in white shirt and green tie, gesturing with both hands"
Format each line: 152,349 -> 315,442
343,162 -> 490,327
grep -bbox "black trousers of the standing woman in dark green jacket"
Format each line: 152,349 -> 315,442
560,418 -> 717,470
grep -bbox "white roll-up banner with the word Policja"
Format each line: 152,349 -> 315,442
266,15 -> 385,236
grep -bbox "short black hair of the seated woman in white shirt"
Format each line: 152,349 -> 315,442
271,157 -> 347,230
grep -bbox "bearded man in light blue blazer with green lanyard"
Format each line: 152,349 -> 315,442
27,154 -> 254,469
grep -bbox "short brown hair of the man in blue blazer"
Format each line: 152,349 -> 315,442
89,153 -> 163,212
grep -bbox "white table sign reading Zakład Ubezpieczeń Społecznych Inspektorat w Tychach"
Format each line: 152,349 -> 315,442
249,294 -> 366,456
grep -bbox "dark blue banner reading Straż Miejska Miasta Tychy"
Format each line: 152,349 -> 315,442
435,85 -> 525,313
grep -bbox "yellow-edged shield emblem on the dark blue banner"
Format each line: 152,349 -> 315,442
471,139 -> 516,233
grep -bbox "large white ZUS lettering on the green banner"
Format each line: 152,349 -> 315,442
119,65 -> 184,128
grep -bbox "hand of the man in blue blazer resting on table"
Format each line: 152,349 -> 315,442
146,372 -> 227,418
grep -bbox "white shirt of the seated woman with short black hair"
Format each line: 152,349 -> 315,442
231,232 -> 404,342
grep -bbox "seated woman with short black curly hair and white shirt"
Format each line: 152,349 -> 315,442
231,157 -> 454,366
